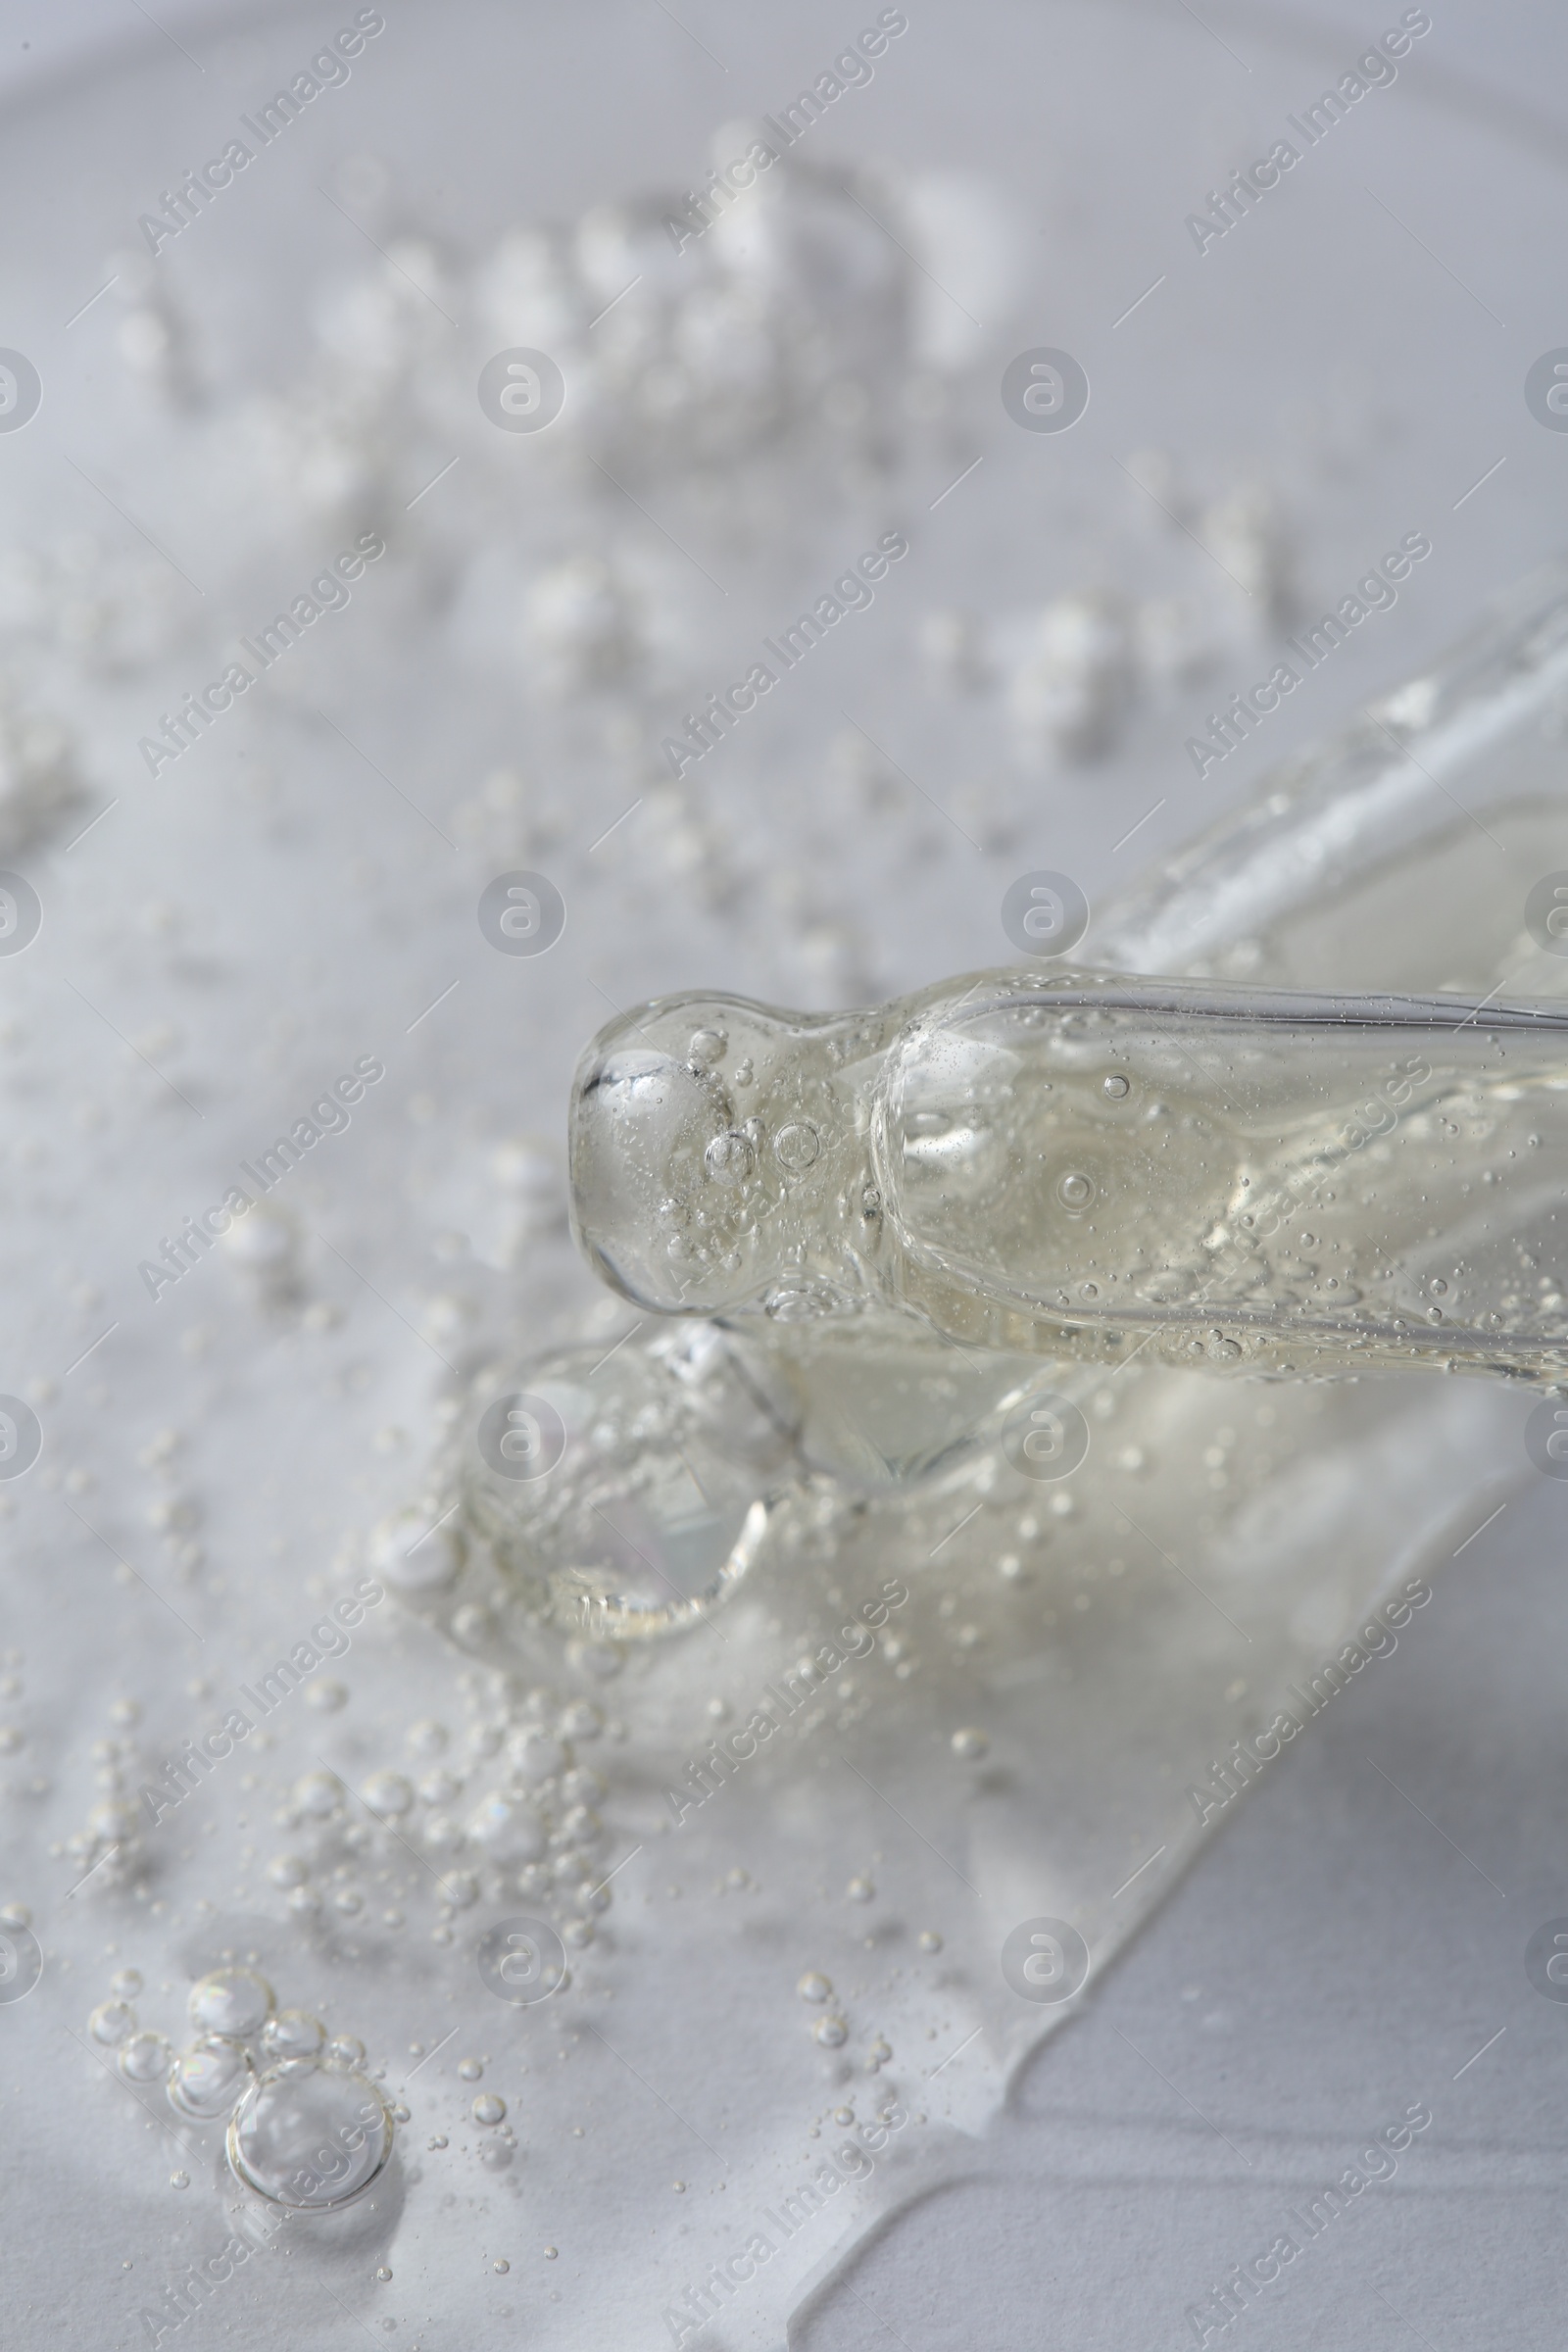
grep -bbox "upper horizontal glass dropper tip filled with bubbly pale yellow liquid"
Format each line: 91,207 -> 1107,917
571,971 -> 1568,1378
